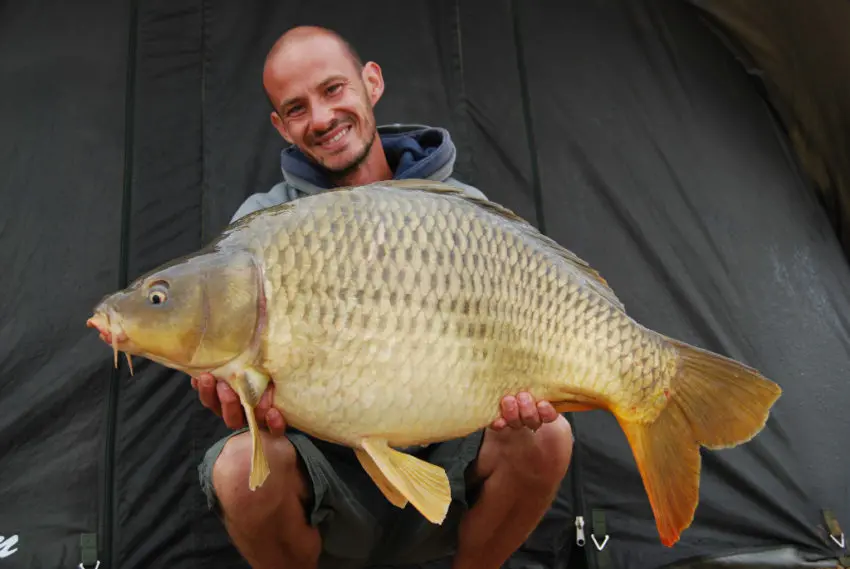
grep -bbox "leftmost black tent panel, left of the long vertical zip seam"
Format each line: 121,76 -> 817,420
0,0 -> 128,569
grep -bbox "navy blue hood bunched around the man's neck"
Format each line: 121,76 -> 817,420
280,124 -> 457,194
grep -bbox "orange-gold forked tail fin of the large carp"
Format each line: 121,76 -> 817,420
619,339 -> 781,547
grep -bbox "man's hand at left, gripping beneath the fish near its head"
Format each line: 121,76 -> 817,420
192,373 -> 286,436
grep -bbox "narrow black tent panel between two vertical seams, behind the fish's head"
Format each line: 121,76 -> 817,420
107,0 -> 245,569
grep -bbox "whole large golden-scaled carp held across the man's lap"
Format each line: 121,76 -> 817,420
88,180 -> 781,546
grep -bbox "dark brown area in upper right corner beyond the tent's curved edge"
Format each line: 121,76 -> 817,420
689,0 -> 850,266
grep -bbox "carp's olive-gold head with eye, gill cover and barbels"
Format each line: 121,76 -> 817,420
87,251 -> 264,374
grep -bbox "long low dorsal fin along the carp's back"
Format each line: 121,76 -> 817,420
354,179 -> 626,312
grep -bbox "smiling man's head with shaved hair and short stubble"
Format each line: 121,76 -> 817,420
263,26 -> 384,176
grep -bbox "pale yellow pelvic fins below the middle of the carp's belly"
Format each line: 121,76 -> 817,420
358,439 -> 452,524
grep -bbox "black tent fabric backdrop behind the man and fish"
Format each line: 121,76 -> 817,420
0,0 -> 850,569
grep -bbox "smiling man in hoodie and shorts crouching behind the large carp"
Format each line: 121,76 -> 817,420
192,27 -> 572,569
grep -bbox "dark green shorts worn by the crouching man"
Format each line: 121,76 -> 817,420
198,429 -> 483,569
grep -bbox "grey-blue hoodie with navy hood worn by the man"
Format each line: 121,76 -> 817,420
231,124 -> 486,221
